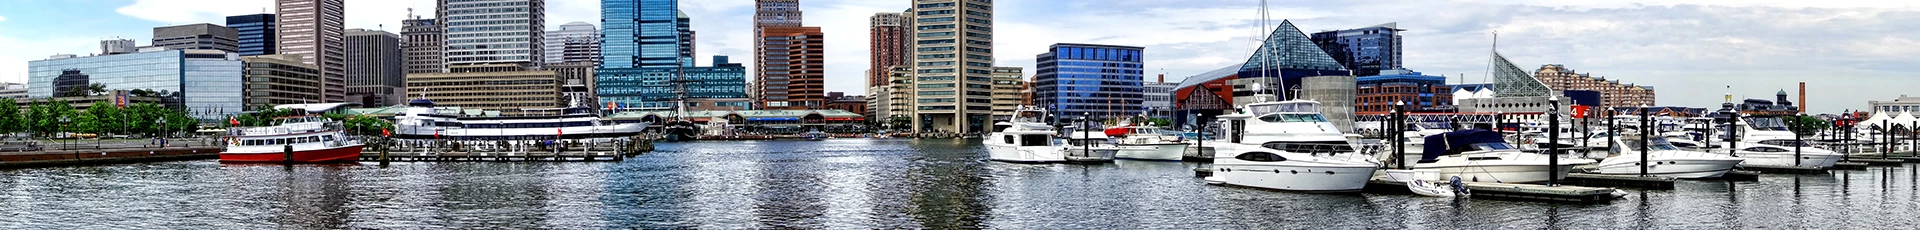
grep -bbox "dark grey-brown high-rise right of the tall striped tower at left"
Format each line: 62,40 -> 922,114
348,29 -> 407,107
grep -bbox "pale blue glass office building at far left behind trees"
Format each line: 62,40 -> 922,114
27,48 -> 244,121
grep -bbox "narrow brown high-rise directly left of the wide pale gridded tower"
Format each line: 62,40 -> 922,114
399,17 -> 447,73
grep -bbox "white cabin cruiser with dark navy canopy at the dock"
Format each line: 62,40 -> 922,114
1413,128 -> 1594,184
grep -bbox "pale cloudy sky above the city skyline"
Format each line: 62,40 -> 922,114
0,0 -> 1920,113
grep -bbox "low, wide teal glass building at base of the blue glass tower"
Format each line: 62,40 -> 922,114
593,56 -> 751,109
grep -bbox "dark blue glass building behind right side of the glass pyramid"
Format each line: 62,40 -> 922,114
1311,23 -> 1405,77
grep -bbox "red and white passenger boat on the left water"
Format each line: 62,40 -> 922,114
221,111 -> 365,163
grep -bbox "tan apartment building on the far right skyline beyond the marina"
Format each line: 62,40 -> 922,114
1534,63 -> 1655,107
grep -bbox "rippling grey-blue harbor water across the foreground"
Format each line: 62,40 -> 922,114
0,140 -> 1920,228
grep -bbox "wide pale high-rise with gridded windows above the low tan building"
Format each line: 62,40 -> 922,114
436,0 -> 547,65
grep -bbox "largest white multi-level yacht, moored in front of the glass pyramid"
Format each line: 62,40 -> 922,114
1206,100 -> 1380,192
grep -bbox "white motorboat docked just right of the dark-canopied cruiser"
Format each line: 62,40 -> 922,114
1594,136 -> 1745,178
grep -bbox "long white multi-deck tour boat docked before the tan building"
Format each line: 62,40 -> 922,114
394,100 -> 649,142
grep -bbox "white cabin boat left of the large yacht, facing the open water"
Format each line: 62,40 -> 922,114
981,107 -> 1068,163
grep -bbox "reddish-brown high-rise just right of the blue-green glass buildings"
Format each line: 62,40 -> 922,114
753,27 -> 828,109
